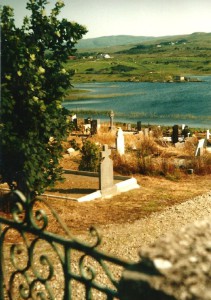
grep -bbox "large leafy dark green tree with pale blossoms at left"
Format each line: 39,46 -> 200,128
0,0 -> 86,194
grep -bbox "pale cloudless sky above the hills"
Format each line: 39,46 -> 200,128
0,0 -> 211,38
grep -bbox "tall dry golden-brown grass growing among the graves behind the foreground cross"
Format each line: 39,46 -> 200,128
62,129 -> 211,180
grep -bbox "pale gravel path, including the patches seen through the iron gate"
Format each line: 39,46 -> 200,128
4,191 -> 211,300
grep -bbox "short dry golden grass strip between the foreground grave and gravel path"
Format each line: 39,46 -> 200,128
43,174 -> 211,234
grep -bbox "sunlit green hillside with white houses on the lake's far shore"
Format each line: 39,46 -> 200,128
67,33 -> 211,82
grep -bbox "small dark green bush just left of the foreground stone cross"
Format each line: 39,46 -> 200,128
79,141 -> 100,172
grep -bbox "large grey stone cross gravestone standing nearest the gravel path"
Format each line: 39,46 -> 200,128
99,145 -> 117,196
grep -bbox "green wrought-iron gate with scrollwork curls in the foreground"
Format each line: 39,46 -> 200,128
0,191 -> 132,300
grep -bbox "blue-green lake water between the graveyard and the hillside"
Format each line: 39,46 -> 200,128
64,76 -> 211,128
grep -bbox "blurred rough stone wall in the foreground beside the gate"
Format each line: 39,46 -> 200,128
119,218 -> 211,300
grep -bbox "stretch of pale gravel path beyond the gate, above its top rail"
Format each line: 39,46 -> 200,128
92,191 -> 211,262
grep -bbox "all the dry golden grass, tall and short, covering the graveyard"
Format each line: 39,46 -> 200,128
0,130 -> 211,237
